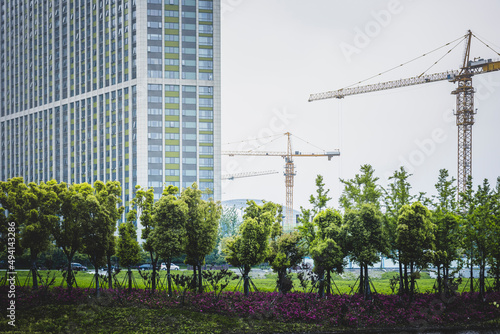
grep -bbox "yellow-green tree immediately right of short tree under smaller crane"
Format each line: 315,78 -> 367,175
310,209 -> 347,297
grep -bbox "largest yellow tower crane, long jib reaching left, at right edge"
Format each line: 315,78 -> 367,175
309,30 -> 500,196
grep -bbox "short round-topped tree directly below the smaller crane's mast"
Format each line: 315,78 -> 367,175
267,231 -> 306,293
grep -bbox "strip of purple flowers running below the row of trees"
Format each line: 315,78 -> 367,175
4,287 -> 500,328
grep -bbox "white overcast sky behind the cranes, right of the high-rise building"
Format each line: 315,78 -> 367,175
221,0 -> 500,209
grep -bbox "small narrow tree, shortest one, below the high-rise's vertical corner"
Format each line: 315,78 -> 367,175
116,222 -> 141,292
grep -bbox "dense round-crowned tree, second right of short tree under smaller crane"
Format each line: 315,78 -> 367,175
344,203 -> 387,299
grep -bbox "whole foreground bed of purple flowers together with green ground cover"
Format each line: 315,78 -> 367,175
0,287 -> 500,333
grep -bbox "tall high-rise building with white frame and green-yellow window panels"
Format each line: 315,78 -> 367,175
0,0 -> 221,222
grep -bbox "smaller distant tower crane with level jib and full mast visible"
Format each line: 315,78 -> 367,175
222,132 -> 340,231
